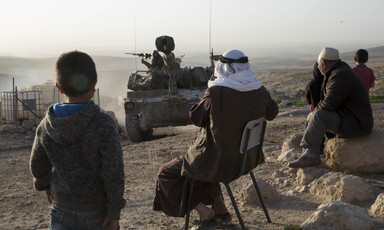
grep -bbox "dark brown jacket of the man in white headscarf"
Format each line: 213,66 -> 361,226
182,86 -> 278,183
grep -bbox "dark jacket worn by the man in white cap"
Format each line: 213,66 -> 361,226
316,61 -> 373,138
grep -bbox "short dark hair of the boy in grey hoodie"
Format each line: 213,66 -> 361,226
56,50 -> 97,97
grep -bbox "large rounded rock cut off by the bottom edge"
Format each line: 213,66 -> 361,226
301,201 -> 374,230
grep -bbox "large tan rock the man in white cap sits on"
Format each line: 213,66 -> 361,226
325,130 -> 384,173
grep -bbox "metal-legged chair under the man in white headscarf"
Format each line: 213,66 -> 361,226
184,118 -> 272,230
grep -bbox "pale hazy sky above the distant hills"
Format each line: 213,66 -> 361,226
0,0 -> 384,57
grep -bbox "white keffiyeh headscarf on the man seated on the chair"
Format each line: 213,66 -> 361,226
208,50 -> 262,92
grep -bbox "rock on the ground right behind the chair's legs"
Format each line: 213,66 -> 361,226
238,179 -> 281,205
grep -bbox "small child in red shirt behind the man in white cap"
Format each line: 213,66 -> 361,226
353,49 -> 376,94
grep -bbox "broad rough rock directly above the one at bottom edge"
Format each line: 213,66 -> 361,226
308,172 -> 376,203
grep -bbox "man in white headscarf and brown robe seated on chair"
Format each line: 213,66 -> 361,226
154,50 -> 278,229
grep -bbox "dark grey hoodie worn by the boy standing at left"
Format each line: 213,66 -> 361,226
30,101 -> 125,220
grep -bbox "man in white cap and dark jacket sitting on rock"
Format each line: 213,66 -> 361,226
289,47 -> 373,168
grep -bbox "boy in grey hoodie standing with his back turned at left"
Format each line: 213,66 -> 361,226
30,51 -> 125,229
